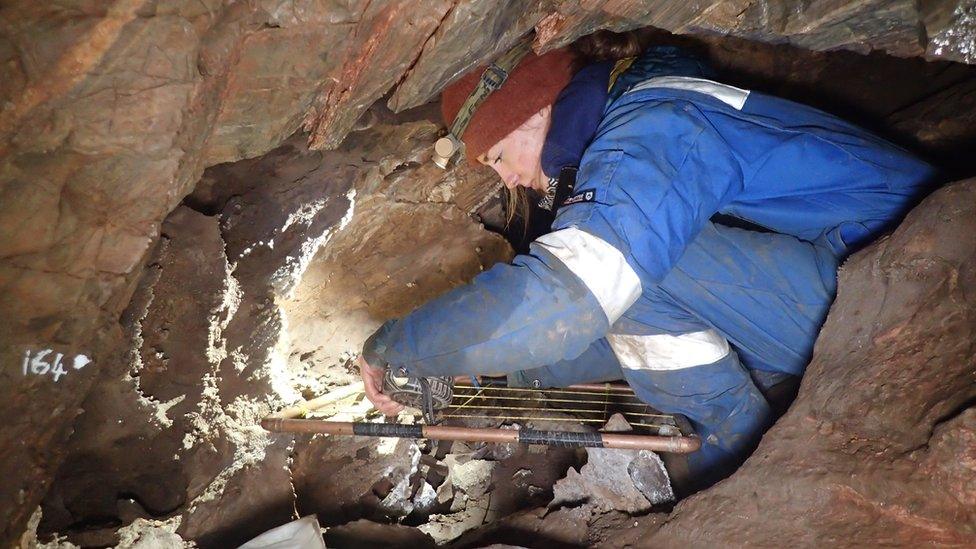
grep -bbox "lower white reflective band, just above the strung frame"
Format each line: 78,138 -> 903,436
607,330 -> 730,371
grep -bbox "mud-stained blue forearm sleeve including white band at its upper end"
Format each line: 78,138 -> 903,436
363,235 -> 640,376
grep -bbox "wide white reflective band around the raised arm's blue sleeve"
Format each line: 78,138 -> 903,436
535,227 -> 642,324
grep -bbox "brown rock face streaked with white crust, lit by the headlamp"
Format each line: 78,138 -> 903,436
40,114 -> 510,547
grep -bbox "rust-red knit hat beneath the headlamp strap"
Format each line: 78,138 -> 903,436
441,48 -> 574,163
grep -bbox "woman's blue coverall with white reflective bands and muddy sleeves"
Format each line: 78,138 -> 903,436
364,48 -> 935,484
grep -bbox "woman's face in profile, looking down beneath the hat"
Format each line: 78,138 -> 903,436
478,106 -> 552,194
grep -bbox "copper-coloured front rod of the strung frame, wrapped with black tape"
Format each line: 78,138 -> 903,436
261,417 -> 701,453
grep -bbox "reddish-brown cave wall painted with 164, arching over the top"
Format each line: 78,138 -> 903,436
0,0 -> 974,543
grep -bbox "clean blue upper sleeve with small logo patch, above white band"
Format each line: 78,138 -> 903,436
554,99 -> 744,286
